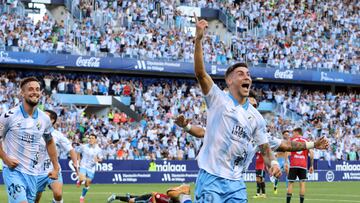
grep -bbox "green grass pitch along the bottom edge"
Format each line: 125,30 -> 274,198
0,182 -> 360,203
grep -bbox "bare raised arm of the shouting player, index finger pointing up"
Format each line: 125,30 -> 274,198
194,14 -> 214,95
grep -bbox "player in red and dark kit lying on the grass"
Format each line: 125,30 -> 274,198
107,185 -> 192,203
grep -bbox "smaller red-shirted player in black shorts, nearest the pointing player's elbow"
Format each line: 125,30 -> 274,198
253,152 -> 266,199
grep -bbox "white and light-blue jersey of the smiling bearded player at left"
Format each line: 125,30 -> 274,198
0,104 -> 53,175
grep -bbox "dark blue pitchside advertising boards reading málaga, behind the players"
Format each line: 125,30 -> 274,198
0,160 -> 360,184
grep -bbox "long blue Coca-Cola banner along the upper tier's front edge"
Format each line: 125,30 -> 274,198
0,51 -> 360,85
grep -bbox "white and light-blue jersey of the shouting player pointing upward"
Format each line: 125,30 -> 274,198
197,84 -> 268,180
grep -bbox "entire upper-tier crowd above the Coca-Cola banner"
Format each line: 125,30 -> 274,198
0,0 -> 360,73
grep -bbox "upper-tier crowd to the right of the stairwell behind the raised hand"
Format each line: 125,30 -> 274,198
209,0 -> 360,73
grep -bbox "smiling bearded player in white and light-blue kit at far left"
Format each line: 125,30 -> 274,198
0,77 -> 59,203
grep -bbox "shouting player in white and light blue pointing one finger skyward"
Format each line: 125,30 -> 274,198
194,13 -> 281,203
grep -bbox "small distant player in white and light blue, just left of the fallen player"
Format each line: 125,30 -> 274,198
77,134 -> 102,203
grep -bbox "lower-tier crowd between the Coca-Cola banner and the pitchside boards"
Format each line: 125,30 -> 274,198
0,71 -> 360,160
